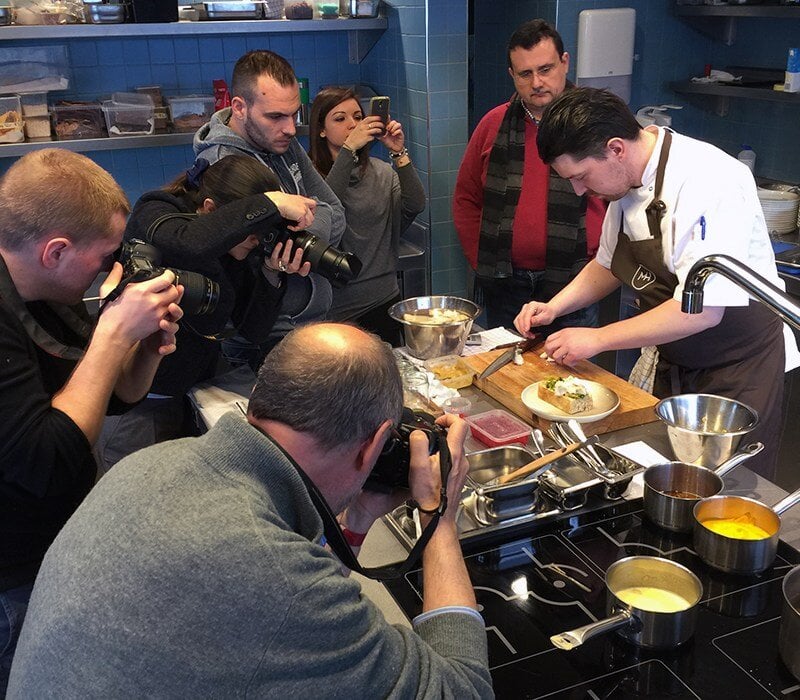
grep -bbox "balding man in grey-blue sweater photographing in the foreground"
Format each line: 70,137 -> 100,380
8,323 -> 492,698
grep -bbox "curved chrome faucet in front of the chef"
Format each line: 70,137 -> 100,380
681,255 -> 800,329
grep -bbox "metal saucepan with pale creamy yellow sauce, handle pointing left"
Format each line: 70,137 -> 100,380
550,557 -> 703,650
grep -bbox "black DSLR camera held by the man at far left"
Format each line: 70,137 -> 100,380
117,238 -> 219,316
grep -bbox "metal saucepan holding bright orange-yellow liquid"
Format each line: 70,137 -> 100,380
693,489 -> 800,574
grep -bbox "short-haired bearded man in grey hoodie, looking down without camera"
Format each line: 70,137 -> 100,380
194,50 -> 345,360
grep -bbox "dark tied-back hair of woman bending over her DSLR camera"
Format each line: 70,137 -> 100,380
164,155 -> 281,209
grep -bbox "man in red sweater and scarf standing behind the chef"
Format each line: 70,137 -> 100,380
453,19 -> 606,331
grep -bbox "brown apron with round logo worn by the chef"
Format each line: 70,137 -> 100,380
611,131 -> 785,478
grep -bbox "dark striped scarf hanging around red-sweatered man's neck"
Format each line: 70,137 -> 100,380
476,93 -> 587,294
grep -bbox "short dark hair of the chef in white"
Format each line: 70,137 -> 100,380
536,87 -> 642,164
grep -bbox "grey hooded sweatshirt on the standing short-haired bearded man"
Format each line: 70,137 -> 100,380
193,107 -> 345,337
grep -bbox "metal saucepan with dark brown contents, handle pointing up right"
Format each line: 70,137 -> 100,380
643,442 -> 764,532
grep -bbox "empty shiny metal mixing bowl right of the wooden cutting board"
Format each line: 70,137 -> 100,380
656,394 -> 758,467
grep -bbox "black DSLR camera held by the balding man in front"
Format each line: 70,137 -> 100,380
364,408 -> 450,493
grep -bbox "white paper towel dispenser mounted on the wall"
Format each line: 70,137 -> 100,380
576,7 -> 636,102
